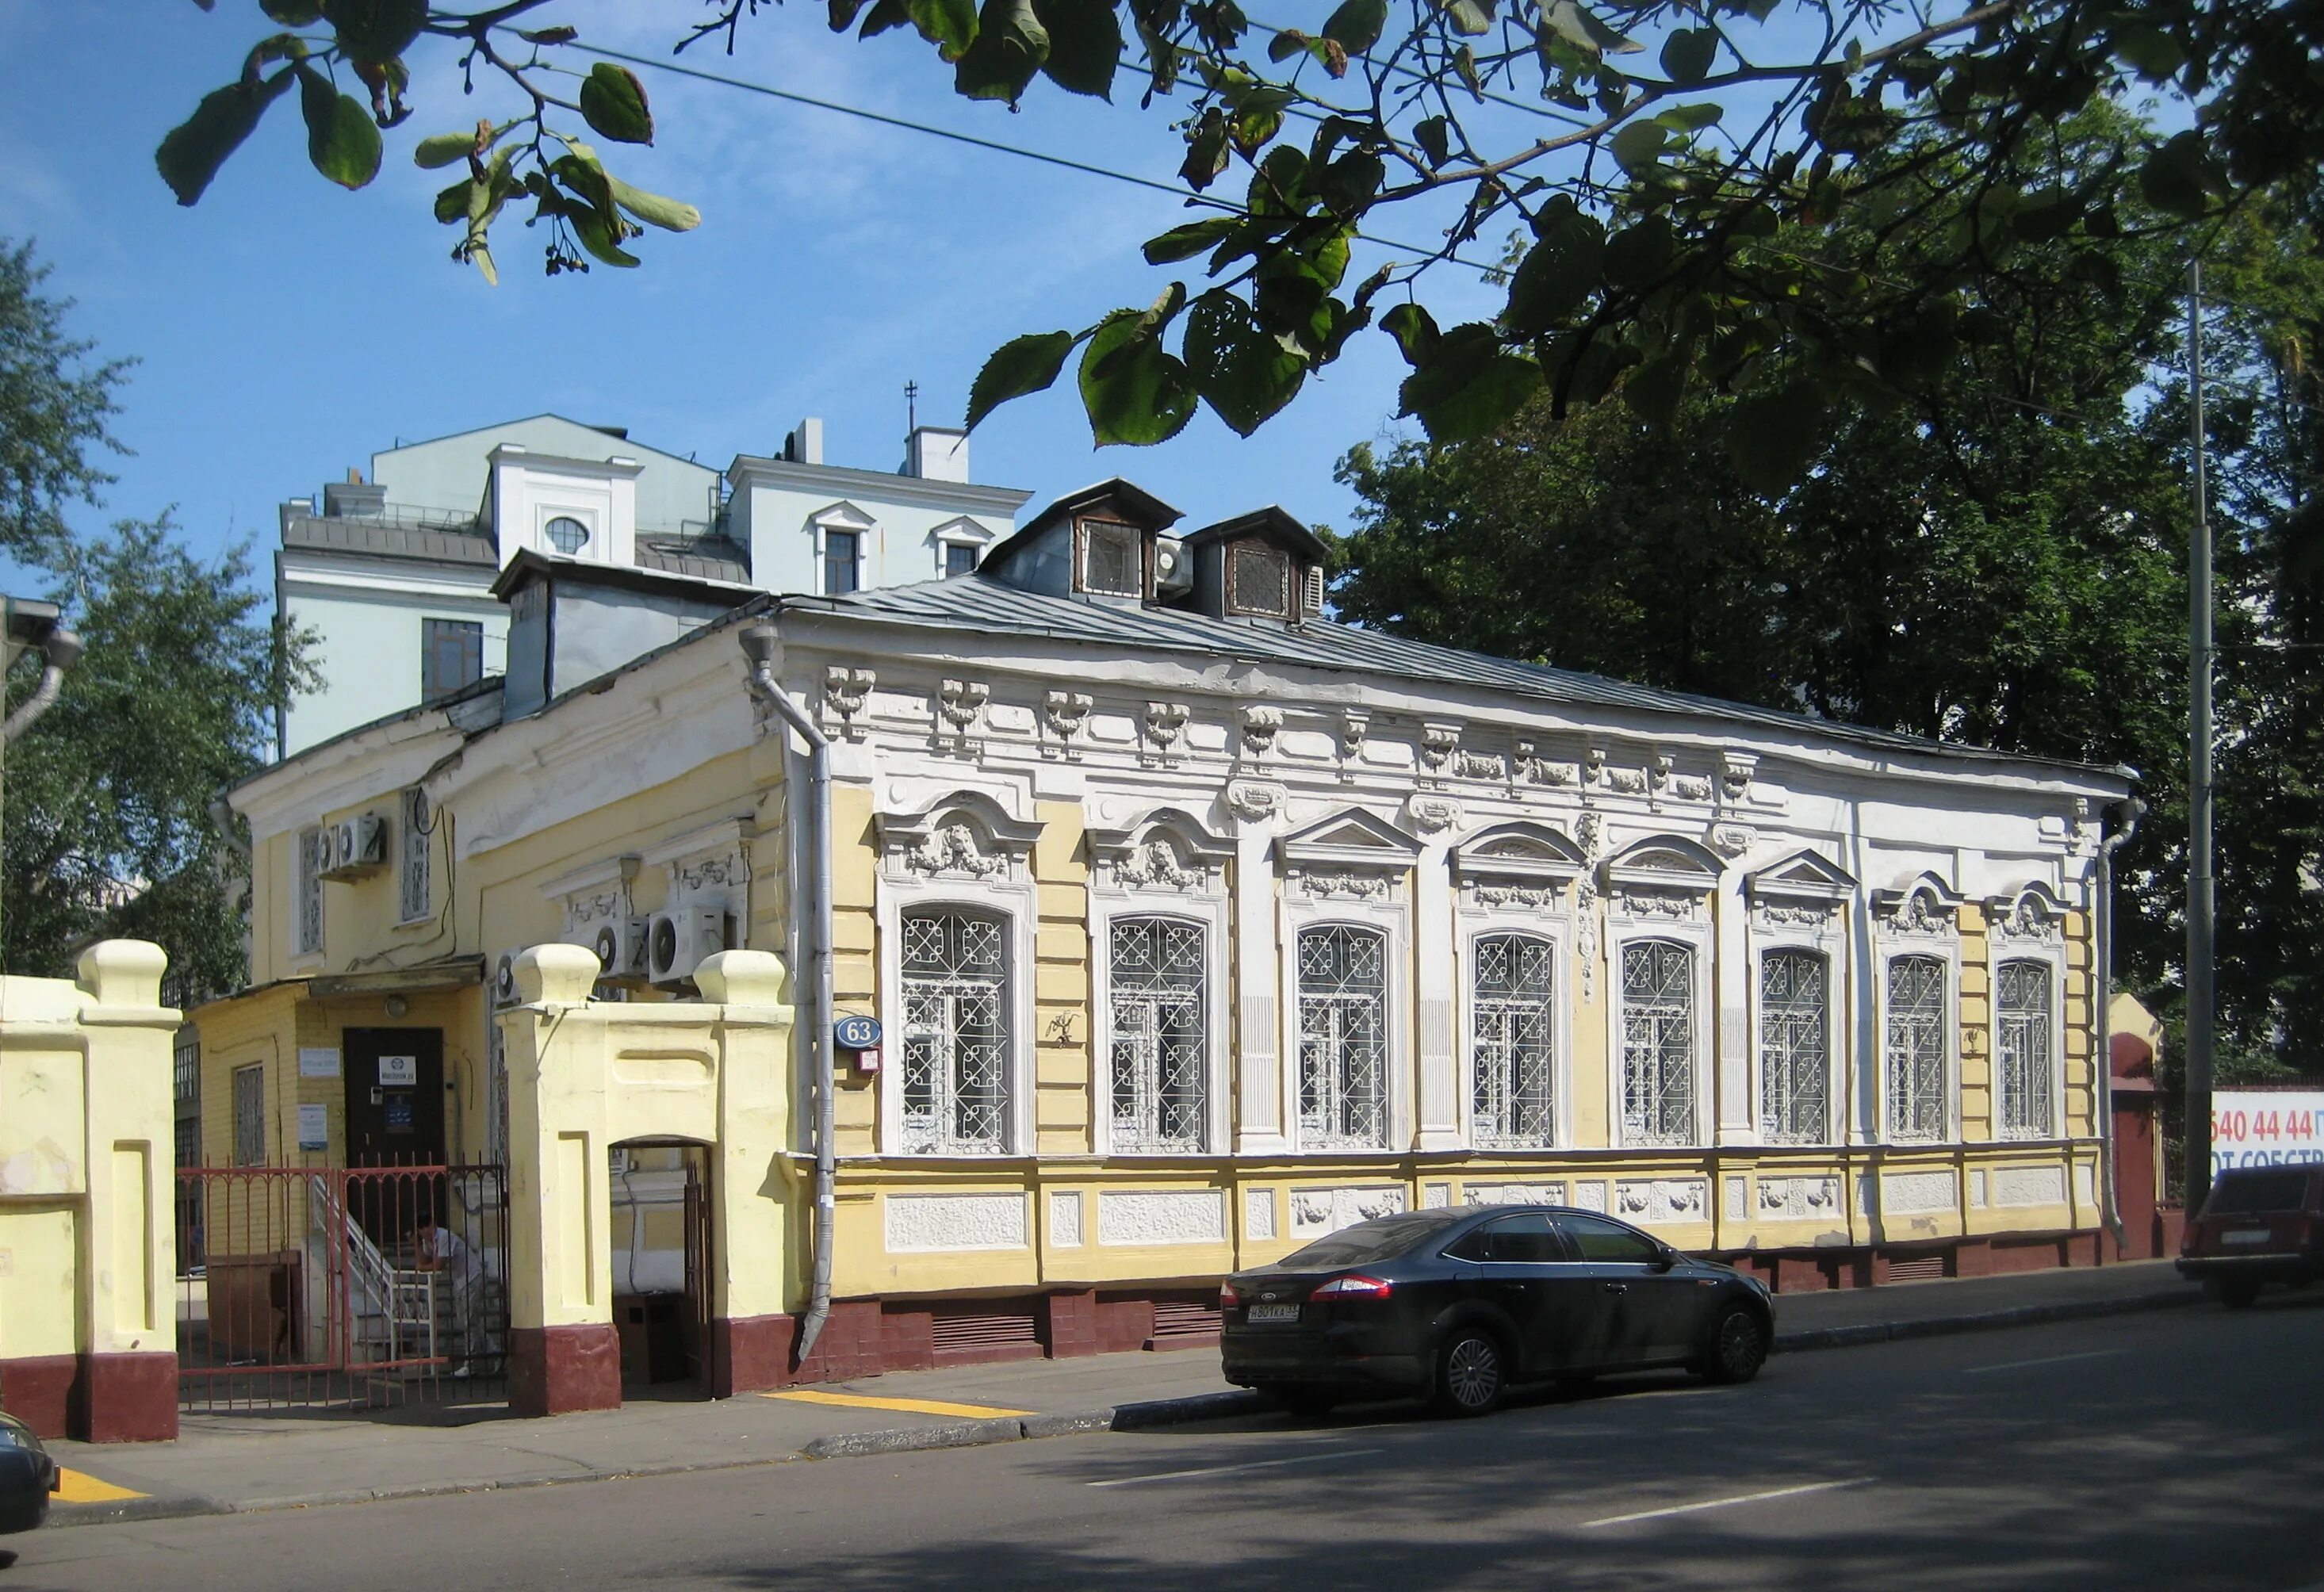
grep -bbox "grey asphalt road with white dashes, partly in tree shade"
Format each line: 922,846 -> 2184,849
0,1292 -> 2324,1592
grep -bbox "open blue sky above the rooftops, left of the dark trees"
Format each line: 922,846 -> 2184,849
0,0 -> 1499,583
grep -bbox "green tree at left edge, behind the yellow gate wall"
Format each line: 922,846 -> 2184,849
0,244 -> 304,1004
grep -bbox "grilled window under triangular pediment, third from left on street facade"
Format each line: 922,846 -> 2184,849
1299,923 -> 1388,1150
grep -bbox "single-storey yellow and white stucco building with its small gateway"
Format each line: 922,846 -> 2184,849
193,481 -> 2131,1408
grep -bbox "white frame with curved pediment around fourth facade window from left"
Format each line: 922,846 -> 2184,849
1453,823 -> 1587,1155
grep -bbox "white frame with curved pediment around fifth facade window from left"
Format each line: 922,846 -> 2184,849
1606,834 -> 1729,1150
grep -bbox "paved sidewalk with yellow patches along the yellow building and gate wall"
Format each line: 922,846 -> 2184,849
49,1262 -> 2199,1525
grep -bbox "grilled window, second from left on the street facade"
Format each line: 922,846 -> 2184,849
1106,918 -> 1208,1150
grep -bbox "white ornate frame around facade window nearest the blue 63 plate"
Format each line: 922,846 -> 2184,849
874,790 -> 1041,1162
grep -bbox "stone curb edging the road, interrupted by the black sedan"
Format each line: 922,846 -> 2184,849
49,1288 -> 2203,1527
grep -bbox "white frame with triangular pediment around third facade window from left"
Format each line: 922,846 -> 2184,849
1276,809 -> 1420,1155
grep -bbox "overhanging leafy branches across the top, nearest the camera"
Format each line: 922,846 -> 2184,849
158,0 -> 2324,460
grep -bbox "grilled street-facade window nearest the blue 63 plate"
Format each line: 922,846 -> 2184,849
902,906 -> 1009,1155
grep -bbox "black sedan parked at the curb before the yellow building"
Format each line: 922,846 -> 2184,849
1218,1206 -> 1773,1415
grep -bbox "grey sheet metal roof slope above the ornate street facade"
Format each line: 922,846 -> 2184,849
781,574 -> 2136,779
